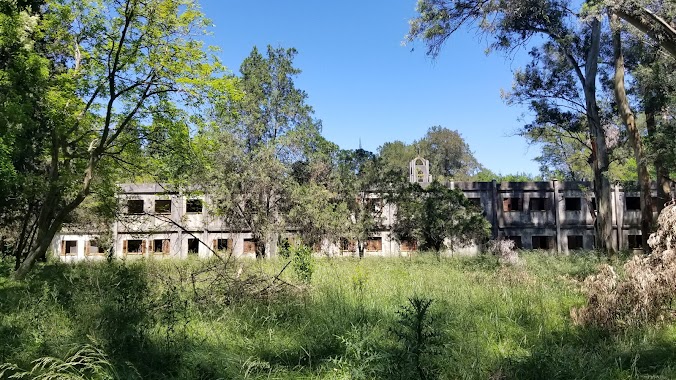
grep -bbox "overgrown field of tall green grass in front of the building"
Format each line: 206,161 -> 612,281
0,253 -> 676,379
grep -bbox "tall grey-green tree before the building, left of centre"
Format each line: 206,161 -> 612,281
195,46 -> 331,257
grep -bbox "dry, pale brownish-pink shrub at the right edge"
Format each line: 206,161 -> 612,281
571,205 -> 676,330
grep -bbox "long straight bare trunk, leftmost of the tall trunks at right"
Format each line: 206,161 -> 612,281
582,19 -> 615,255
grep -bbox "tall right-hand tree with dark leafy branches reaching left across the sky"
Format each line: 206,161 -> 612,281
407,0 -> 614,253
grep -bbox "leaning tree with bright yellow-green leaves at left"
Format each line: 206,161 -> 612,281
7,0 -> 232,278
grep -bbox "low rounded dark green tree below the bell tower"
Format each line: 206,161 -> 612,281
389,181 -> 490,252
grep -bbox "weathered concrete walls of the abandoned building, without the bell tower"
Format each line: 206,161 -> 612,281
52,181 -> 672,261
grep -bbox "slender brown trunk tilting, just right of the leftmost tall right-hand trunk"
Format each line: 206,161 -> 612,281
609,11 -> 653,254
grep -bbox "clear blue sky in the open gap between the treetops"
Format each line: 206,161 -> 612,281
201,0 -> 539,174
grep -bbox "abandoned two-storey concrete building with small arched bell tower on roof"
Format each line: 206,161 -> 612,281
52,157 -> 673,261
